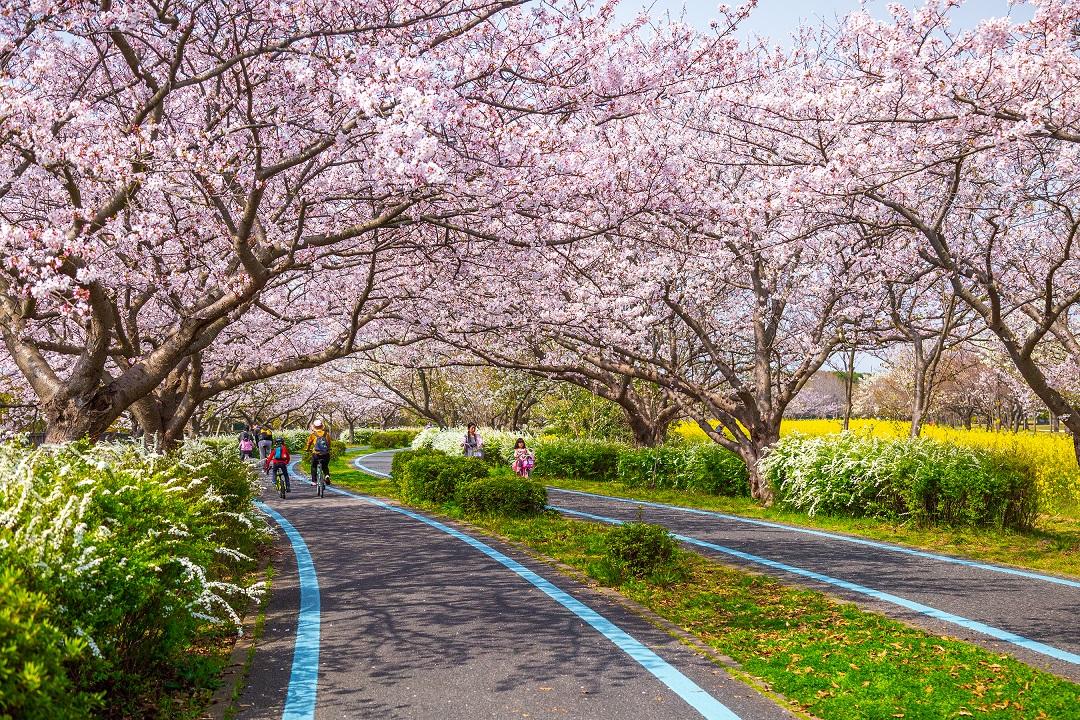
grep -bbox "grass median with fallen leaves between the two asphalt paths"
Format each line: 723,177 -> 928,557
332,453 -> 1080,720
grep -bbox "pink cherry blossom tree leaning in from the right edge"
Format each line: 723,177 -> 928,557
786,0 -> 1080,458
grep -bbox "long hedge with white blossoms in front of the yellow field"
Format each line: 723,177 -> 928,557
762,433 -> 1038,530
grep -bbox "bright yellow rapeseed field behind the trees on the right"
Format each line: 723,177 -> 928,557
673,419 -> 1080,517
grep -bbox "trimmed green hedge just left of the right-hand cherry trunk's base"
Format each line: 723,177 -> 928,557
618,444 -> 750,497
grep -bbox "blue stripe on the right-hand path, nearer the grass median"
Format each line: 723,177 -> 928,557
549,505 -> 1080,665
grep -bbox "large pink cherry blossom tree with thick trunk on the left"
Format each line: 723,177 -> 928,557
0,0 -> 682,440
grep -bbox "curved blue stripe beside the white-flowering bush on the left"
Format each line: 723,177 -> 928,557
255,501 -> 320,720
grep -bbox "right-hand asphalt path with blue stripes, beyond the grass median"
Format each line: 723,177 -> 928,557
363,451 -> 1080,681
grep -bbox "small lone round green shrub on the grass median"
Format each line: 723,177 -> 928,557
592,520 -> 685,584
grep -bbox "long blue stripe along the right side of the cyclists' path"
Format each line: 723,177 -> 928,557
327,483 -> 740,720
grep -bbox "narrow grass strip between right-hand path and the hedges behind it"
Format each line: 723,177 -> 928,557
546,479 -> 1080,576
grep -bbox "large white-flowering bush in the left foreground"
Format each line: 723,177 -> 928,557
0,443 -> 268,718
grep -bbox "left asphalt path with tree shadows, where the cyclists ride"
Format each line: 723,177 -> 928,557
239,462 -> 793,720
